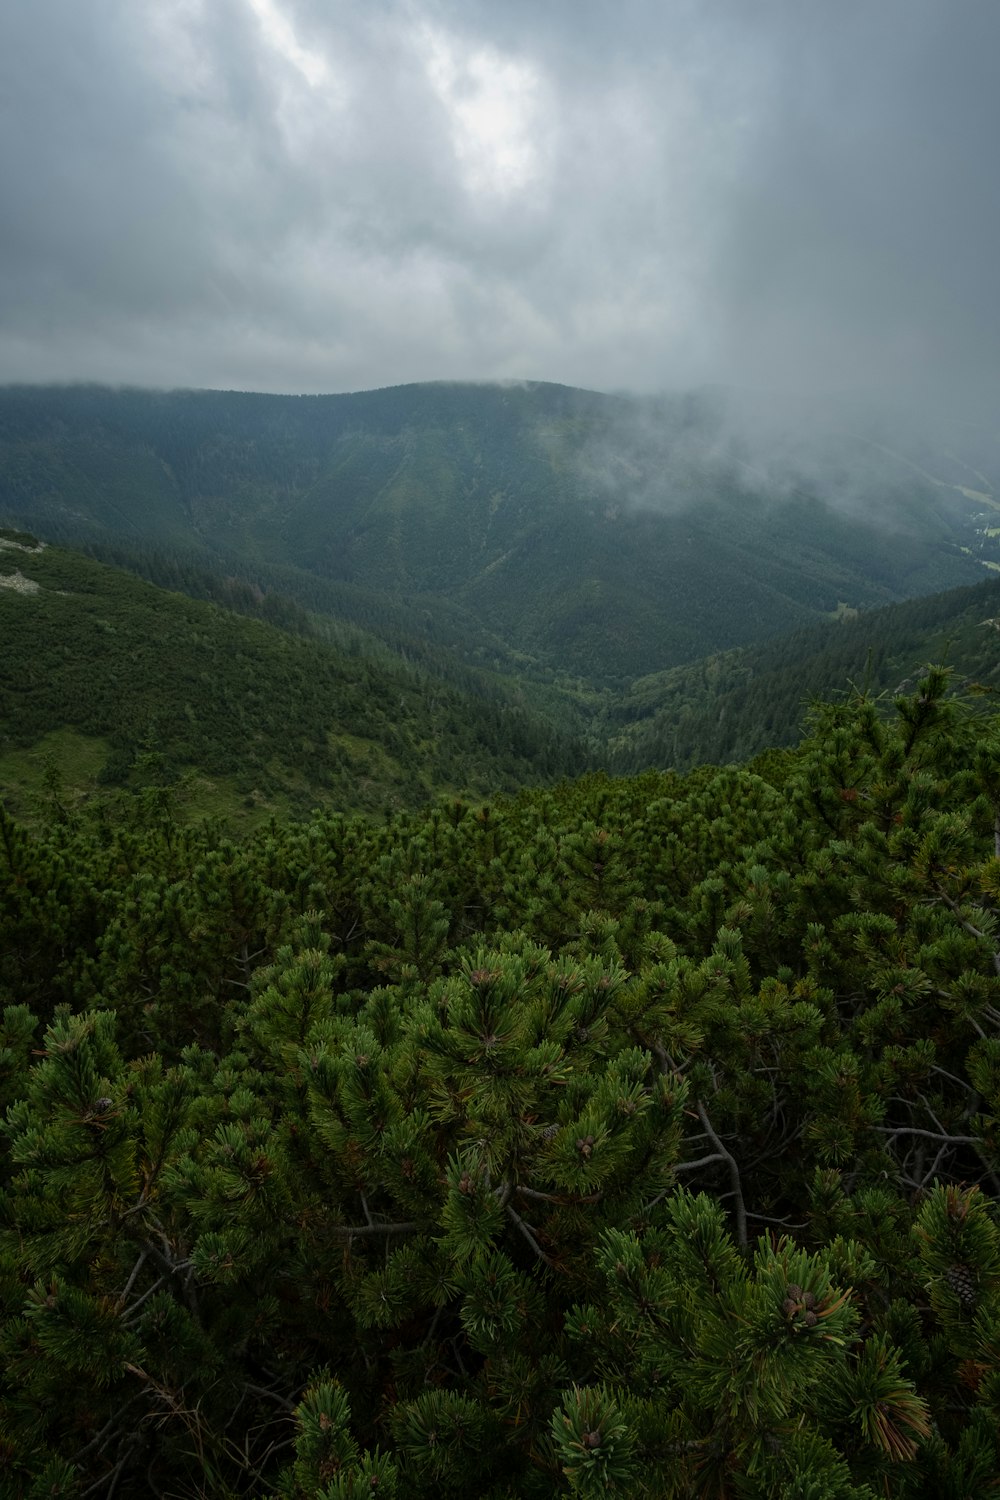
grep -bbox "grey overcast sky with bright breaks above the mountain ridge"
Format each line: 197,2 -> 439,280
0,0 -> 1000,410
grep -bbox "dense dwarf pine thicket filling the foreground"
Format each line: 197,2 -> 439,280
0,671 -> 1000,1500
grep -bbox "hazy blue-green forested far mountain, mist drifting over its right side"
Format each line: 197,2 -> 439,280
0,384 -> 1000,683
